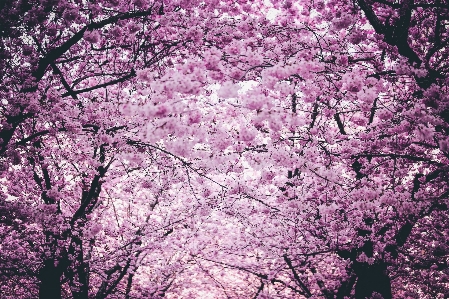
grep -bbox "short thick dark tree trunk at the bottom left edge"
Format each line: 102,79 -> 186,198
39,259 -> 61,299
